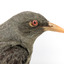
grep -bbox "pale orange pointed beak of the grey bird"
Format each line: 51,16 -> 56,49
43,22 -> 64,33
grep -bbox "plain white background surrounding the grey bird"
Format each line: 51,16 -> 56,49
0,0 -> 64,64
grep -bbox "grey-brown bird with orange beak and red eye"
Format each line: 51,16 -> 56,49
0,11 -> 64,64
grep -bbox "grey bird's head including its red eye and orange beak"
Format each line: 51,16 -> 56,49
16,11 -> 64,39
